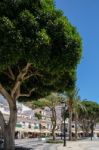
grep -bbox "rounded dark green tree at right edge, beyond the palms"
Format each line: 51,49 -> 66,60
78,100 -> 99,139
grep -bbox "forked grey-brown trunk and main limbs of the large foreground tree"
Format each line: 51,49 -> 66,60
0,63 -> 31,150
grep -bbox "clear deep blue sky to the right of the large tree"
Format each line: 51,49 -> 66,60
56,0 -> 99,103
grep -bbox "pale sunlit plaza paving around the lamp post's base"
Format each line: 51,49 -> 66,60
16,139 -> 99,150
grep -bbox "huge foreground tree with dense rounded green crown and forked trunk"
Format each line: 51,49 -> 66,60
0,0 -> 82,150
